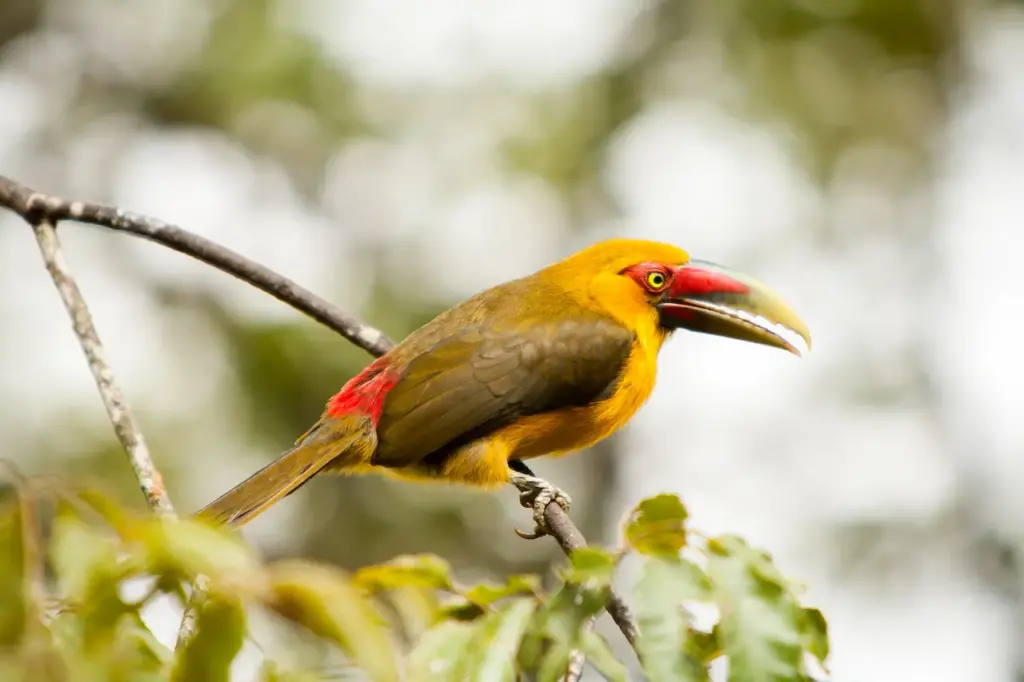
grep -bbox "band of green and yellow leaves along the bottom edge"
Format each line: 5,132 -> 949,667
0,479 -> 828,682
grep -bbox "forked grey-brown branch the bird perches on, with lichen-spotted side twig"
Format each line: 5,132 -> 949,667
0,175 -> 637,647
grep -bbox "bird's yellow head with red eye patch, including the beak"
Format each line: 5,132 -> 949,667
555,240 -> 811,355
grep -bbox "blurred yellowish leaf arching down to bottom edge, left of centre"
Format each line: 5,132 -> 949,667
267,561 -> 400,682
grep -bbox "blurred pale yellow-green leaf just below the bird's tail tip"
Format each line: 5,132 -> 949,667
137,518 -> 260,588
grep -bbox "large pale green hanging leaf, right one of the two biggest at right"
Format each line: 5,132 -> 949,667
708,536 -> 804,682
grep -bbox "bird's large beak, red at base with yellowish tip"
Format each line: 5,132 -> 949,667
655,260 -> 811,355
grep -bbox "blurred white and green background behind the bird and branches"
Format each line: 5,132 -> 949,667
0,0 -> 1024,682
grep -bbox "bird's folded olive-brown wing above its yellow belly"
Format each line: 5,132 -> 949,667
373,316 -> 634,467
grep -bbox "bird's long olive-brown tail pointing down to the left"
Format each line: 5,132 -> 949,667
196,419 -> 377,526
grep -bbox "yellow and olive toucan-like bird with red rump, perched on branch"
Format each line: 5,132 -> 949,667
196,239 -> 811,538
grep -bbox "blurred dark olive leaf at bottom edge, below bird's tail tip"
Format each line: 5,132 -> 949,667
171,595 -> 246,682
